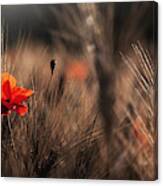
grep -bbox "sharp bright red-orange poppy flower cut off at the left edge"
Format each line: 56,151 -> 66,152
1,73 -> 33,116
